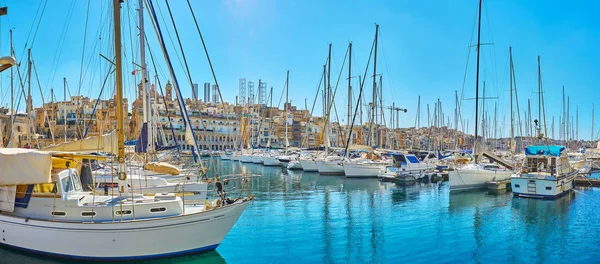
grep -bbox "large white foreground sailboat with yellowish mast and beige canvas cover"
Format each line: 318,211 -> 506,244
0,0 -> 251,260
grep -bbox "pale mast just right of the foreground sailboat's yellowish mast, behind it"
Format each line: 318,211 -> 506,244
138,0 -> 154,157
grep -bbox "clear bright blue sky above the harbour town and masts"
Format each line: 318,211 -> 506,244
0,0 -> 600,139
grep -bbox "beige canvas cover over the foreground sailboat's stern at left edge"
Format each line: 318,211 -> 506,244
0,148 -> 52,186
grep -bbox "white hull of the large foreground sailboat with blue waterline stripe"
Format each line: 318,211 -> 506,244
0,202 -> 248,260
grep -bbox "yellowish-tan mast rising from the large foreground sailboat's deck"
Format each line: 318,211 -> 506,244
113,0 -> 127,193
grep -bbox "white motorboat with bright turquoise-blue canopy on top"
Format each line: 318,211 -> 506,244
510,146 -> 578,199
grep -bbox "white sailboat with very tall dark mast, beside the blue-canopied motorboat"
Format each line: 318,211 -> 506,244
448,0 -> 513,191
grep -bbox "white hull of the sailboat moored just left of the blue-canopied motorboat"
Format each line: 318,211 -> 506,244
448,163 -> 513,191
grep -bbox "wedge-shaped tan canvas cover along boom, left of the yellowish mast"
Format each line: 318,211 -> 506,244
44,130 -> 119,155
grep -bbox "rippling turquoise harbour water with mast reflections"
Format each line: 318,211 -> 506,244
0,161 -> 600,263
